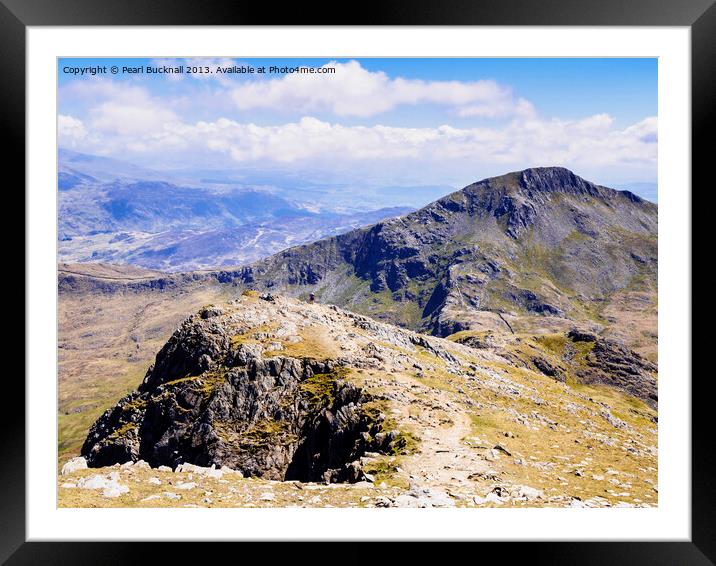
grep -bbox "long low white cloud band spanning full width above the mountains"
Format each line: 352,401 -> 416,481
62,111 -> 657,186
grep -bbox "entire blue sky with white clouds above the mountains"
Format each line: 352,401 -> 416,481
58,57 -> 658,193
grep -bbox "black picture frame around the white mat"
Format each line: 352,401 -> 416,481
0,0 -> 716,565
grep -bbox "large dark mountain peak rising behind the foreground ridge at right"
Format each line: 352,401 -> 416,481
223,167 -> 658,344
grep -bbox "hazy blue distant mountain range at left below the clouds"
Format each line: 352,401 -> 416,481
58,150 -> 412,271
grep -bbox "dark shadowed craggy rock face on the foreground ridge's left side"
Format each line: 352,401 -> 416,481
82,300 -> 406,481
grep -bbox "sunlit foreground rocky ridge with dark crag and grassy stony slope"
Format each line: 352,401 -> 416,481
71,292 -> 656,507
